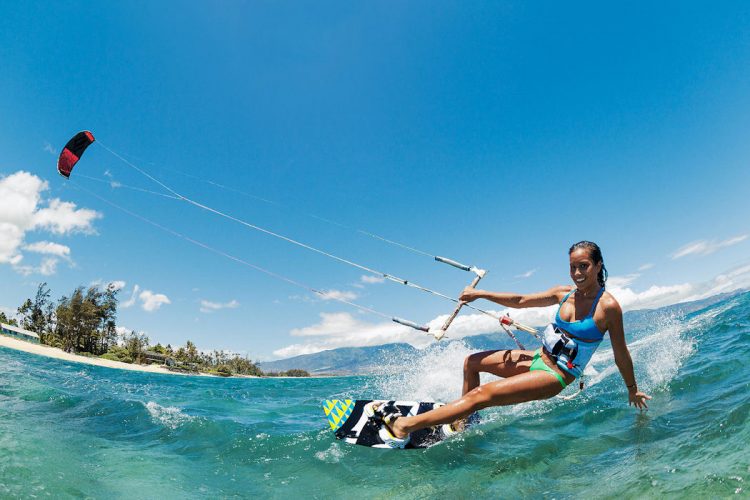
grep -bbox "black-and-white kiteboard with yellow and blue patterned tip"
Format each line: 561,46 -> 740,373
323,399 -> 477,449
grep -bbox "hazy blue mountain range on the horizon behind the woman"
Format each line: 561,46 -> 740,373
260,290 -> 747,375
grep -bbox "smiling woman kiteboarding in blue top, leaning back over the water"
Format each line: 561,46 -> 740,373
366,241 -> 651,447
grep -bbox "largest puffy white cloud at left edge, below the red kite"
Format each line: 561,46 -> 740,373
0,171 -> 101,275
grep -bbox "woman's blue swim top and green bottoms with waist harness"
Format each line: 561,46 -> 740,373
529,287 -> 604,388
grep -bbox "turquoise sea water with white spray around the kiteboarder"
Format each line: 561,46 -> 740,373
0,293 -> 750,498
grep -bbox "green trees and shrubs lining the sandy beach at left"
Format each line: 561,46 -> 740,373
7,283 -> 310,377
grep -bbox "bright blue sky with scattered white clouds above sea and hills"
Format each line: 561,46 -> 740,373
0,1 -> 750,360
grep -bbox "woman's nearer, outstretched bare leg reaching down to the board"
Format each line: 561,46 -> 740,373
391,370 -> 562,437
